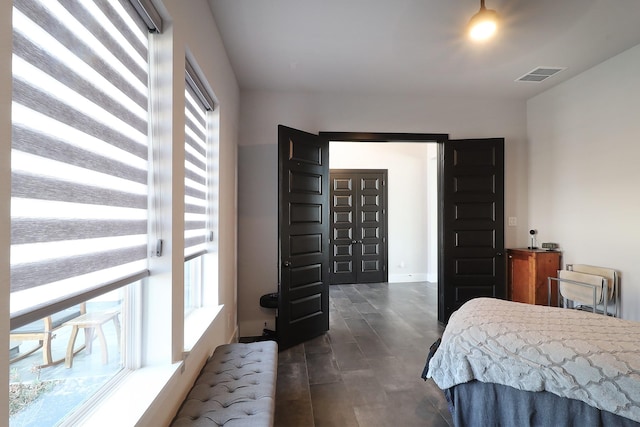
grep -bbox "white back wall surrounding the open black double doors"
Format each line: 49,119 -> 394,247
238,91 -> 527,336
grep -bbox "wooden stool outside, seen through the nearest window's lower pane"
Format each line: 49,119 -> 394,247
64,310 -> 120,368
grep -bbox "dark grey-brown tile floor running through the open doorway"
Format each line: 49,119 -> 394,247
275,282 -> 453,427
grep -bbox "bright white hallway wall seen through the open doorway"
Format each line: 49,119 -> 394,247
329,141 -> 438,282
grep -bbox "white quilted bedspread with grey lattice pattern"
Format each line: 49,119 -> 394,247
427,298 -> 640,422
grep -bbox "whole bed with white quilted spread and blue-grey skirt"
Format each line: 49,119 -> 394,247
423,298 -> 640,426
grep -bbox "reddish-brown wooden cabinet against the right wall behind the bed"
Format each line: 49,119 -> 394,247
507,249 -> 561,306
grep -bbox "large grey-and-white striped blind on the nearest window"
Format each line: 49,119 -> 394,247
11,0 -> 148,328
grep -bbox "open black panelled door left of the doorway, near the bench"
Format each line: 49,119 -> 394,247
276,126 -> 329,349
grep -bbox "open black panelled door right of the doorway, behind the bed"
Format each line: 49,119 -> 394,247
438,138 -> 506,323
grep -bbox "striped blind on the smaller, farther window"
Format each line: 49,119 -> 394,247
184,70 -> 211,260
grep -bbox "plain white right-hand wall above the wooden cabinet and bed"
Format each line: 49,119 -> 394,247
527,45 -> 640,320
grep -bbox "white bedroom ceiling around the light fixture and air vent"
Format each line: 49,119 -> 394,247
209,0 -> 640,99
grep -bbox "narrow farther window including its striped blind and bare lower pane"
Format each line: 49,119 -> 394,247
184,60 -> 217,316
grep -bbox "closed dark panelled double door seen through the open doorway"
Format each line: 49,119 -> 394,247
330,169 -> 388,284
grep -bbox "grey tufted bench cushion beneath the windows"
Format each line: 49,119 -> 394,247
171,341 -> 278,427
